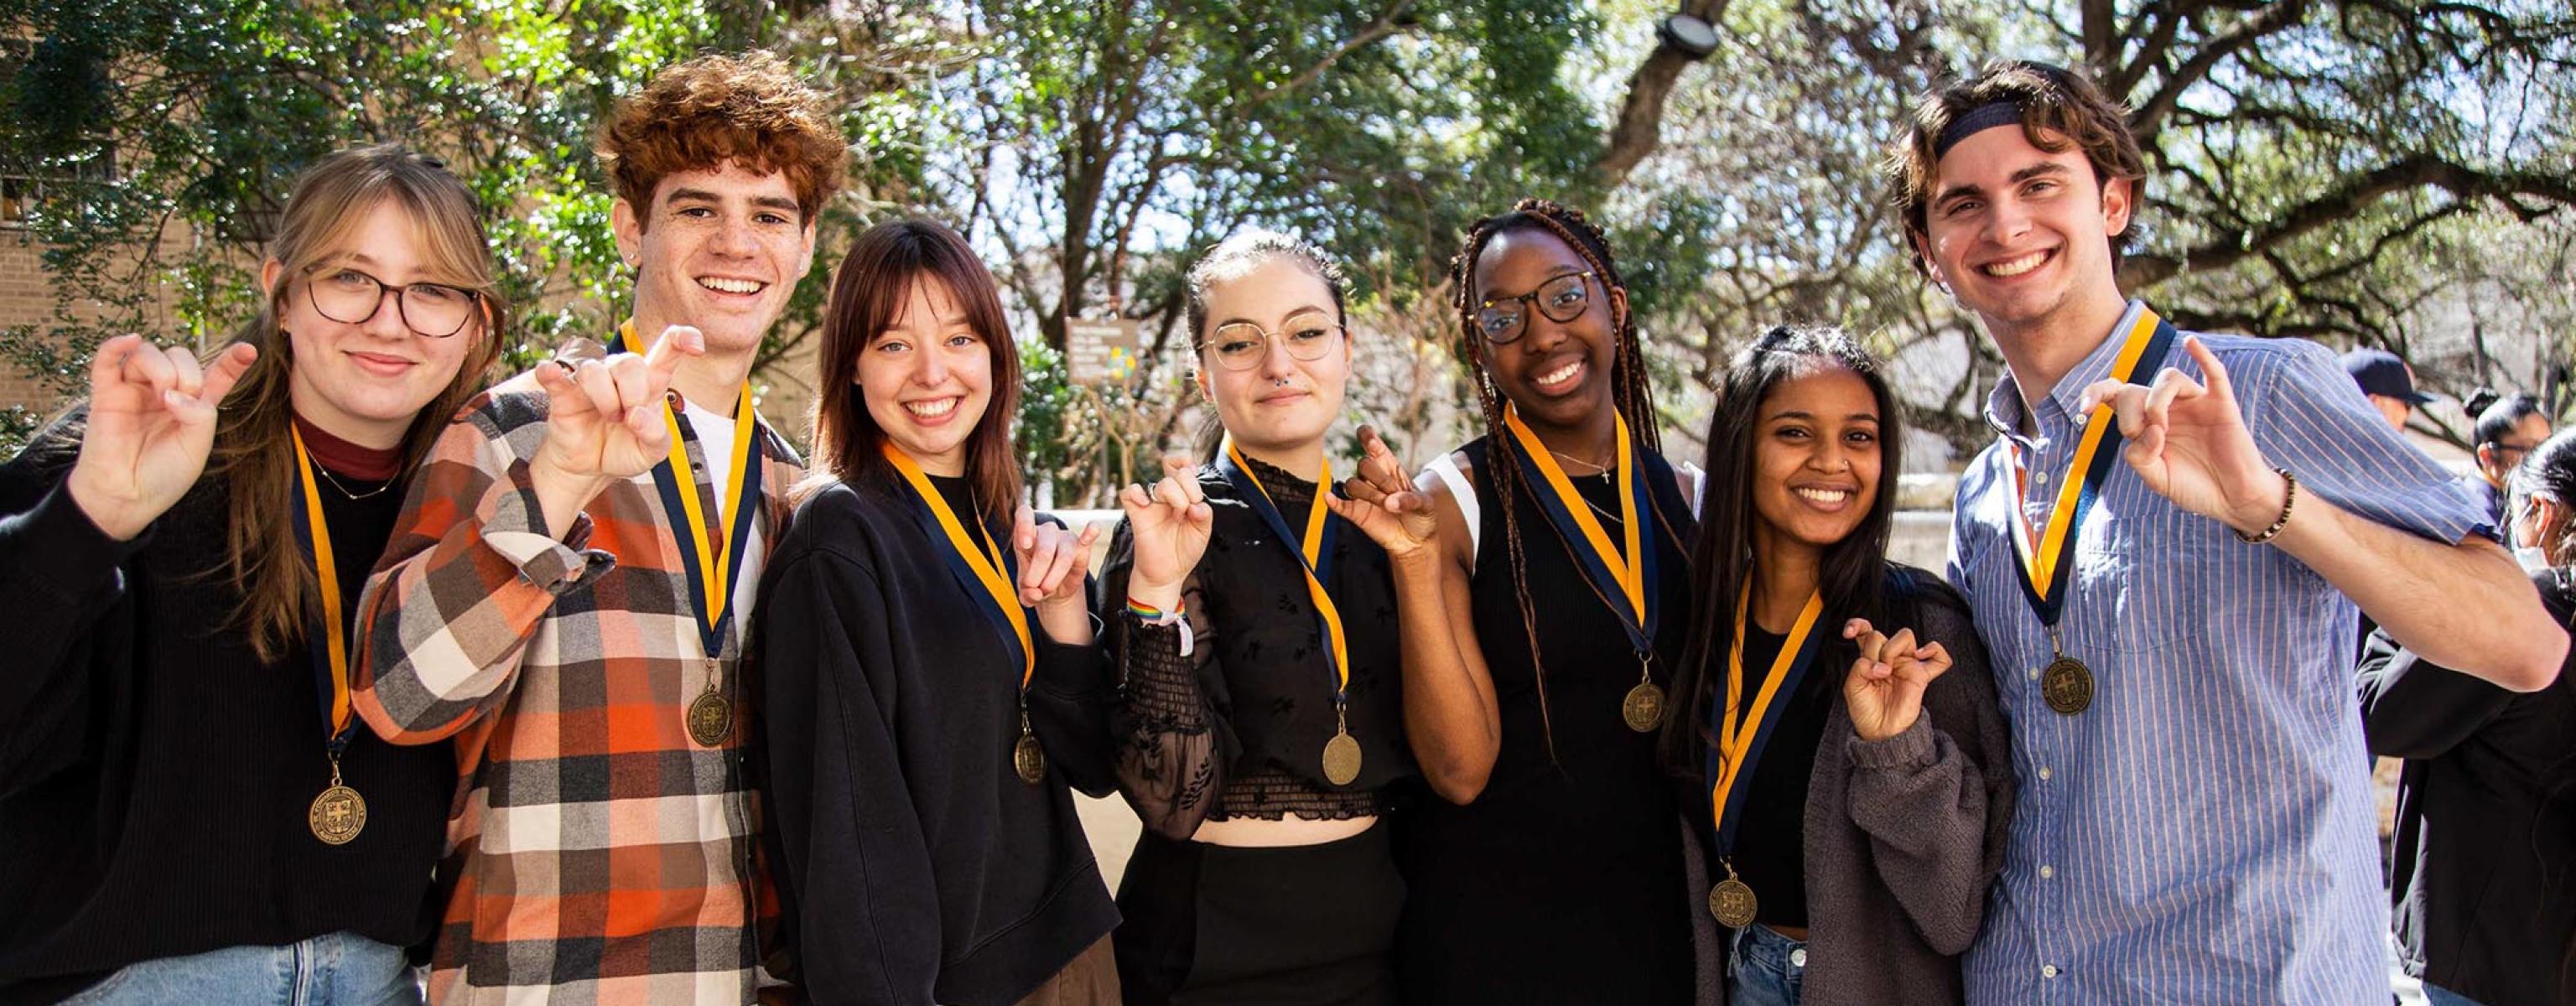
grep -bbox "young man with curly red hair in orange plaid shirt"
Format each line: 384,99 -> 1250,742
356,51 -> 845,1003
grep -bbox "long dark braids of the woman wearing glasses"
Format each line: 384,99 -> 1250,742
1451,198 -> 1685,761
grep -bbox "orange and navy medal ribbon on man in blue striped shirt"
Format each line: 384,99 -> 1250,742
2004,303 -> 2177,628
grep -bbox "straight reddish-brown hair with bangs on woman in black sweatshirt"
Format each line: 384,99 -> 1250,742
798,219 -> 1021,522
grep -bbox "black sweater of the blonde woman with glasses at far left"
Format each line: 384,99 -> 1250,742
0,437 -> 456,1003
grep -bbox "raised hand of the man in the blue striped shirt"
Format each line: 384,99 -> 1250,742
2081,337 -> 2290,532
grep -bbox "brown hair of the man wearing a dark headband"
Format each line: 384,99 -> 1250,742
1877,60 -> 2146,272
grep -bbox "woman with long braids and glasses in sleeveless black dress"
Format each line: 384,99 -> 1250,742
1396,200 -> 1695,1003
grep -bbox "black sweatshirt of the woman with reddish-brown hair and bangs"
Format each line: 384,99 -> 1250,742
755,474 -> 1118,1006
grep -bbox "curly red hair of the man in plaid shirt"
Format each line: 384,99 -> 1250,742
595,49 -> 850,224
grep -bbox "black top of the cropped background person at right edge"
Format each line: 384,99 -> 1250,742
2360,568 -> 2576,1006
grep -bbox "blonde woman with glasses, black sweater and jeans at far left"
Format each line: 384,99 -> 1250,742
0,147 -> 507,1003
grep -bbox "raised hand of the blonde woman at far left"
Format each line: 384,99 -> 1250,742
65,334 -> 260,541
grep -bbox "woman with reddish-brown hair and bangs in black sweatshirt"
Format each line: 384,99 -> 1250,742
755,221 -> 1118,1006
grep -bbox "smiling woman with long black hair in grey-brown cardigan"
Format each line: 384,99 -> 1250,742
1661,329 -> 2014,1006
